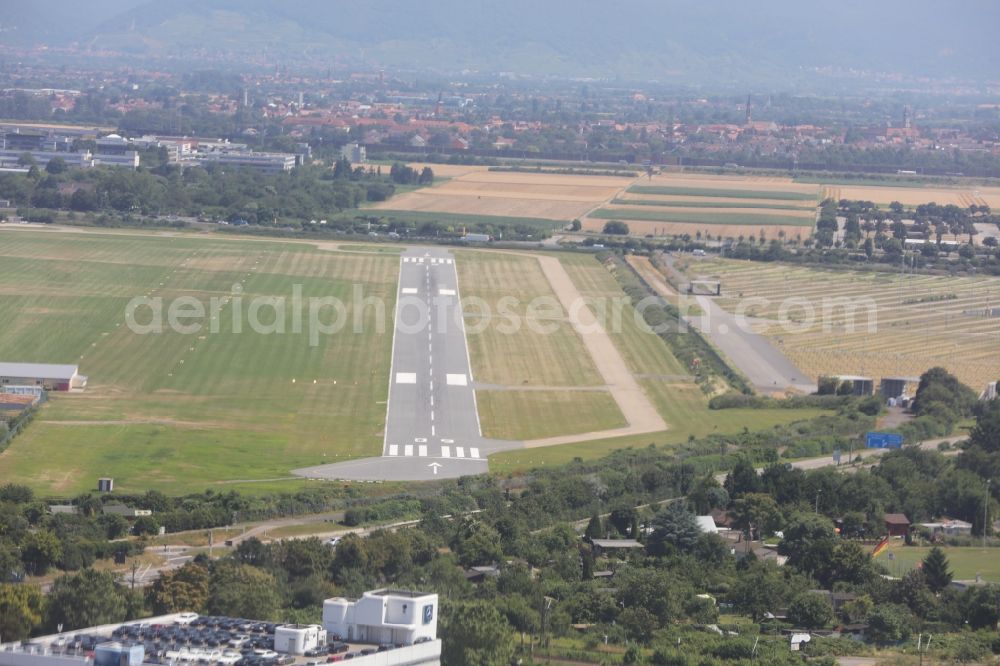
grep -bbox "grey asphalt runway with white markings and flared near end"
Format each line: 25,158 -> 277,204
294,248 -> 521,481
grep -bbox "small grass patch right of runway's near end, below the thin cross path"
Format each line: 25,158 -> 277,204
476,390 -> 625,440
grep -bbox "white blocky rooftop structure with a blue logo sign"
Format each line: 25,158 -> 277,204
323,589 -> 438,645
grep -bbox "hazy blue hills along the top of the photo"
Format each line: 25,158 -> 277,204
7,0 -> 1000,85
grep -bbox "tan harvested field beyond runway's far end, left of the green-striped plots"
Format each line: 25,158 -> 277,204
374,165 -> 633,222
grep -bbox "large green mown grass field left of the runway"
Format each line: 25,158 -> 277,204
0,231 -> 398,495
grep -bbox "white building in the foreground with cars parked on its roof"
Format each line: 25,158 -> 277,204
0,590 -> 441,666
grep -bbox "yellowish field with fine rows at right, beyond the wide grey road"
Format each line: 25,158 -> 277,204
688,254 -> 1000,392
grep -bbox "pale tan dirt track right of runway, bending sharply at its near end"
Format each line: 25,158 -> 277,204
524,255 -> 667,448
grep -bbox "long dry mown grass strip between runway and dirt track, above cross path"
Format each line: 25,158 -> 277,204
456,251 -> 602,384
